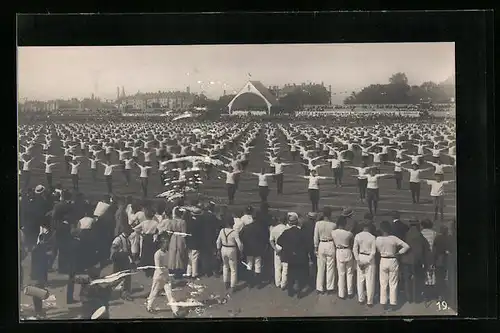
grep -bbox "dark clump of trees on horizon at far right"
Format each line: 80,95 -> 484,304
344,72 -> 455,104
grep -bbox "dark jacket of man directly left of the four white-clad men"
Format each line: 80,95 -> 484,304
277,227 -> 309,265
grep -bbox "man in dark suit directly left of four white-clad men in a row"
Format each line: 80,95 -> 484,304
276,213 -> 309,298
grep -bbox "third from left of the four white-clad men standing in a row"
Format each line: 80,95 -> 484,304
352,221 -> 377,307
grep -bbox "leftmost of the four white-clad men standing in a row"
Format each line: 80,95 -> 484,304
314,207 -> 337,294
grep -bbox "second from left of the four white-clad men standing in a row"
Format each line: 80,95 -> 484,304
332,219 -> 354,299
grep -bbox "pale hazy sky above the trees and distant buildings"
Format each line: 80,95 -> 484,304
17,43 -> 455,102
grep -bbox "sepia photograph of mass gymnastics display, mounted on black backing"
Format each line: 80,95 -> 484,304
17,42 -> 458,321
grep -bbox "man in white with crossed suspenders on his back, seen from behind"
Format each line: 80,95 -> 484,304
216,216 -> 243,292
